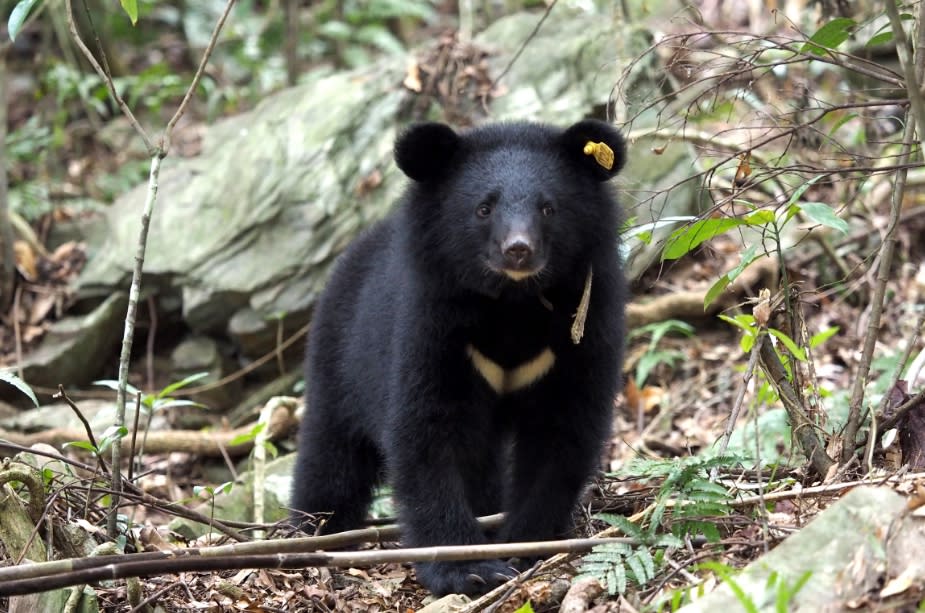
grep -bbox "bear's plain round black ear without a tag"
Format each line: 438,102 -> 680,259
395,122 -> 461,182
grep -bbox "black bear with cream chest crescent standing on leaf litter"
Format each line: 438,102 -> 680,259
292,120 -> 626,594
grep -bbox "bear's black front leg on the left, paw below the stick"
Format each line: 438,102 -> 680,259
387,394 -> 516,595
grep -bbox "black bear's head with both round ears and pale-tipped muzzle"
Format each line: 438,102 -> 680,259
395,120 -> 626,295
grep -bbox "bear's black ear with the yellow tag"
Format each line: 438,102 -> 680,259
561,119 -> 626,181
